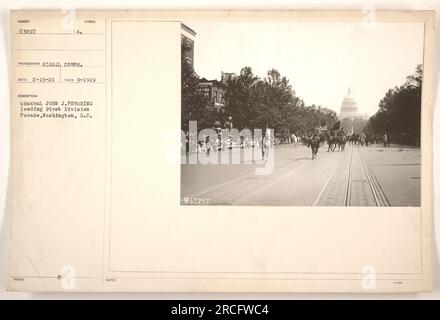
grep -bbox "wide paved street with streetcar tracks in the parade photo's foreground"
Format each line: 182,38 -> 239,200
181,144 -> 420,206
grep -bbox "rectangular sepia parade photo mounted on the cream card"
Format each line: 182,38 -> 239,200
180,20 -> 424,207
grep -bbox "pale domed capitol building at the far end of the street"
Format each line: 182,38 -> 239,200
339,88 -> 369,135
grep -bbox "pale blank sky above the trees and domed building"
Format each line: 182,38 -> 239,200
184,21 -> 424,115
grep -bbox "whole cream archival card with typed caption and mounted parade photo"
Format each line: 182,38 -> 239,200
4,6 -> 438,296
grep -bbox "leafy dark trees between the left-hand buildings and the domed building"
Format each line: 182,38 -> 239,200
225,67 -> 337,137
